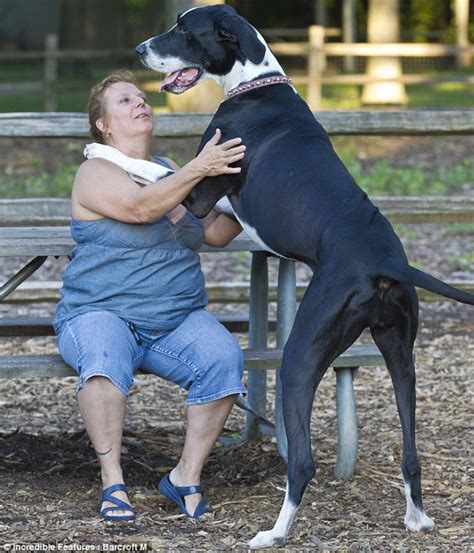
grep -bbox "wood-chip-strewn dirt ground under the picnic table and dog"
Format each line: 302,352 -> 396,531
0,139 -> 474,553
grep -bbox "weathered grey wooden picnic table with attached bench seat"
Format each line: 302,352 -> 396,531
0,220 -> 382,477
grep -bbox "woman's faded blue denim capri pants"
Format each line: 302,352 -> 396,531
58,309 -> 245,405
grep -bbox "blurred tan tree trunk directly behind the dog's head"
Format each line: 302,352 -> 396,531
167,0 -> 225,112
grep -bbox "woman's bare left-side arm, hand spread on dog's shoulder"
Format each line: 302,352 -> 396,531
72,131 -> 245,223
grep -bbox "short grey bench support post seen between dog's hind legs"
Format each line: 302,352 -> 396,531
334,367 -> 358,478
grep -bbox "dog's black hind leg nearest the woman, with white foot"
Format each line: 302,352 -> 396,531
249,275 -> 364,548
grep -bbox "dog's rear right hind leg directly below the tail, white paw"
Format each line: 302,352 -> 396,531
371,284 -> 434,532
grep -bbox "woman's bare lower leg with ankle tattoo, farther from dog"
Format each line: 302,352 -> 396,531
77,376 -> 131,516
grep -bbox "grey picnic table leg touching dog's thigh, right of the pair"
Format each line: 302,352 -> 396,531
275,259 -> 296,462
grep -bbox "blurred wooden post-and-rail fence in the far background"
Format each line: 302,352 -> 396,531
0,25 -> 474,111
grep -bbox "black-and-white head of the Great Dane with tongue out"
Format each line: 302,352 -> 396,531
136,5 -> 267,94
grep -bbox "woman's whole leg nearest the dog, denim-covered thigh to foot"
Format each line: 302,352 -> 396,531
142,310 -> 245,515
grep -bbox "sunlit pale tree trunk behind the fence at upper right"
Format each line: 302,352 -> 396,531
361,0 -> 407,105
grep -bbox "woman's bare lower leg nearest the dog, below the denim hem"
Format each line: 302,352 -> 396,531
170,395 -> 237,515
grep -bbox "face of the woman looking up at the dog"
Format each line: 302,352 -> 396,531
98,82 -> 153,141
